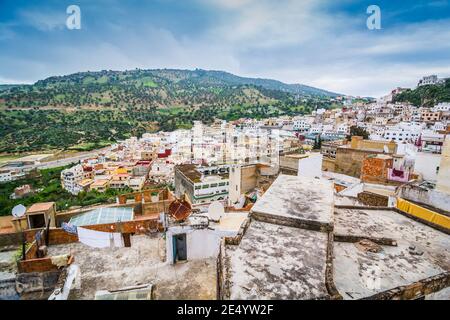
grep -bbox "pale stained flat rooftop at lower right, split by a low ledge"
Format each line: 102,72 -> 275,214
333,209 -> 450,299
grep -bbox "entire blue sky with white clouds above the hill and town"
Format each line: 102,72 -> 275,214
0,0 -> 450,97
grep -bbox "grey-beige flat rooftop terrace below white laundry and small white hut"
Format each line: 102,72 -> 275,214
48,234 -> 217,300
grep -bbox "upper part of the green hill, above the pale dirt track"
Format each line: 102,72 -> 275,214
0,69 -> 337,108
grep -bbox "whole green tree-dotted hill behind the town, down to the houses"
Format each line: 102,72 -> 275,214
0,69 -> 342,154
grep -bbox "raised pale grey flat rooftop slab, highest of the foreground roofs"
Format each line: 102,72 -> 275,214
251,175 -> 334,225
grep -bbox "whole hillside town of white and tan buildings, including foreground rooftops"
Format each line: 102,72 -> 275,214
0,76 -> 450,300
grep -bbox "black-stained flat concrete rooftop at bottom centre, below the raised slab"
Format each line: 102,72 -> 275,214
225,221 -> 328,300
